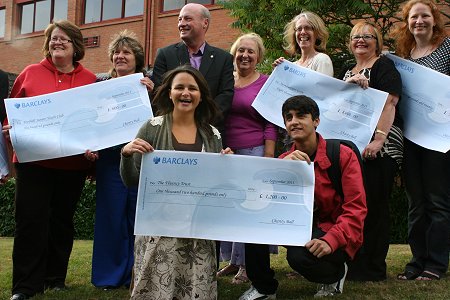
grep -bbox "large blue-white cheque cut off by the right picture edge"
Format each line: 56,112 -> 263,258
387,54 -> 450,153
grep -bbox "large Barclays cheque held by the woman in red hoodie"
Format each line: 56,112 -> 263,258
5,74 -> 153,162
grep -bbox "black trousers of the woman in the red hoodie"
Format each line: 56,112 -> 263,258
12,163 -> 86,295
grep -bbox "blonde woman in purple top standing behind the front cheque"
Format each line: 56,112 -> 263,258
217,33 -> 278,284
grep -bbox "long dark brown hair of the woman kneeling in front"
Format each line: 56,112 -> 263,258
153,65 -> 221,135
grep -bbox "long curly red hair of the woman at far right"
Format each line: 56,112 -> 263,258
392,0 -> 447,57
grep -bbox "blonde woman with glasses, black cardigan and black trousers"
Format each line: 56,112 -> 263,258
338,21 -> 403,281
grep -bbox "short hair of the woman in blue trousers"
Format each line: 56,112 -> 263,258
108,29 -> 145,77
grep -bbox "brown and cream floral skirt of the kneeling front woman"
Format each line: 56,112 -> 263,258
131,236 -> 217,300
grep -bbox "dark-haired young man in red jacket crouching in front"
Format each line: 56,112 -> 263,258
240,96 -> 367,300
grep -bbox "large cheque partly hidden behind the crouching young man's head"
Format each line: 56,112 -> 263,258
252,60 -> 388,153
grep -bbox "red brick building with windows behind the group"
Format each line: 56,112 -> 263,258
0,0 -> 243,74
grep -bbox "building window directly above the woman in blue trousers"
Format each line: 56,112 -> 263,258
84,0 -> 144,24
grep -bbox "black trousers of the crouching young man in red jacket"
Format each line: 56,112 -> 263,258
245,228 -> 348,294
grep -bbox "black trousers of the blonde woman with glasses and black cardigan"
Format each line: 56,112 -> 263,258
347,156 -> 398,281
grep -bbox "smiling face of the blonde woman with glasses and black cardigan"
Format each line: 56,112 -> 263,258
350,25 -> 377,57
